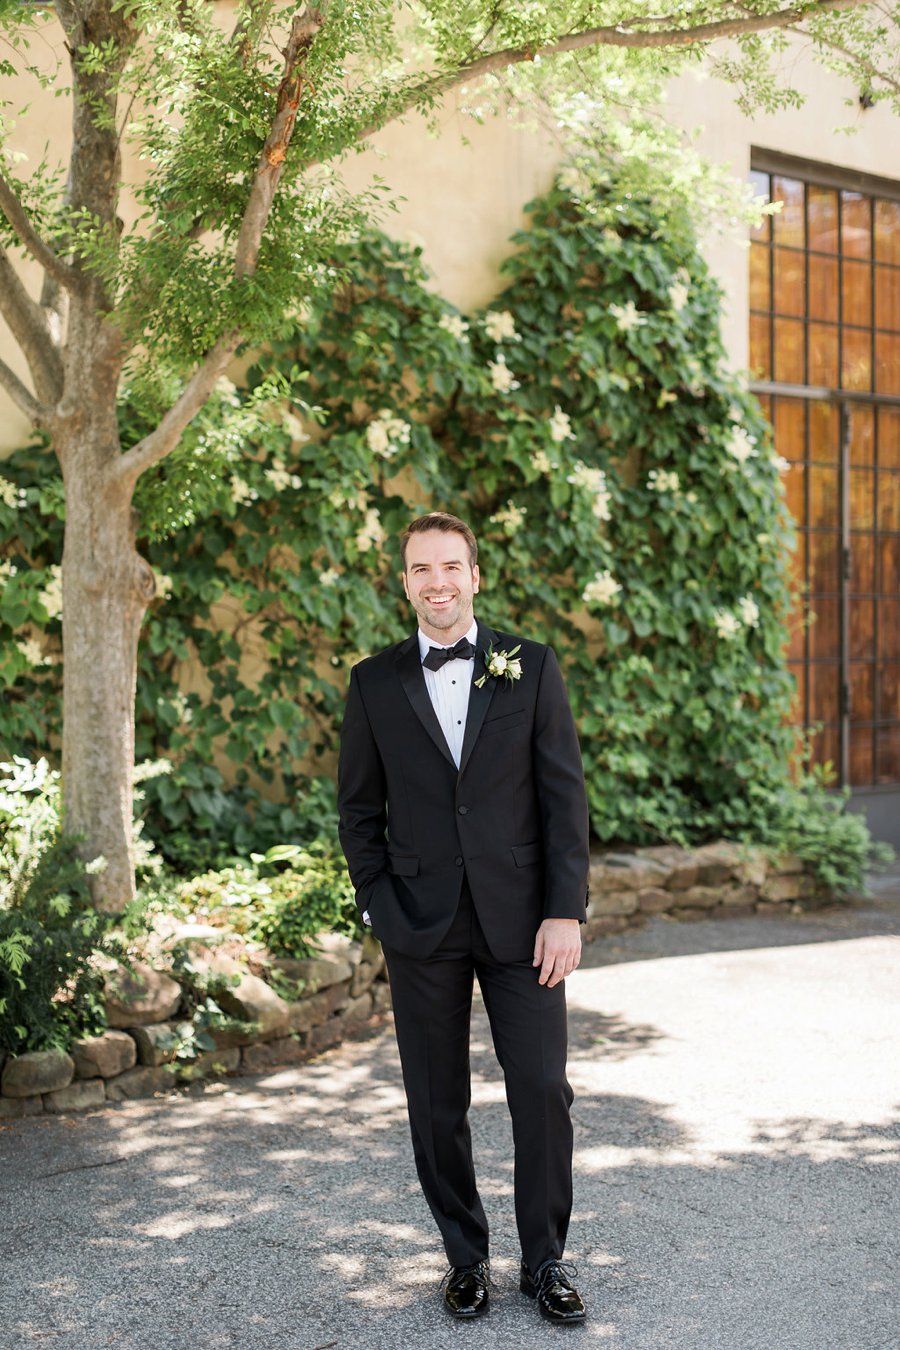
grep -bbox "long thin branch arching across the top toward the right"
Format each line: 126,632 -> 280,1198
315,0 -> 869,157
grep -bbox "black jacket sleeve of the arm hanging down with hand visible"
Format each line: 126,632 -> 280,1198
533,647 -> 590,922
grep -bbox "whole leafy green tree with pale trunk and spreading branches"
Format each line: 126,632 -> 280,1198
0,0 -> 900,909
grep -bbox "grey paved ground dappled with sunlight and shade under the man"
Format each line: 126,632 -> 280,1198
0,868 -> 900,1350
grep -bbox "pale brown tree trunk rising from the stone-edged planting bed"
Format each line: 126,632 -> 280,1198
55,371 -> 155,911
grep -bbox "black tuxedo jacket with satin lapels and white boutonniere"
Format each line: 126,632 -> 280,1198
339,624 -> 588,961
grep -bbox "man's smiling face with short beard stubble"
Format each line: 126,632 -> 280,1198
403,529 -> 479,647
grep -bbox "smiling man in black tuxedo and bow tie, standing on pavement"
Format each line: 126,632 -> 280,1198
339,512 -> 588,1323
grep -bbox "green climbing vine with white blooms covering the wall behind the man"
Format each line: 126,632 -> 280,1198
0,166 -> 814,865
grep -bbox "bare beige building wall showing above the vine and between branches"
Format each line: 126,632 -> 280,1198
0,26 -> 900,448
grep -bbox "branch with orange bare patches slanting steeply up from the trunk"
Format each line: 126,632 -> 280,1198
113,8 -> 325,482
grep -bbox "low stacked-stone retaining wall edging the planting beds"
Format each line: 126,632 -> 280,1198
0,840 -> 831,1119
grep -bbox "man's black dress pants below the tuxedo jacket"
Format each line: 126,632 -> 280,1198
385,886 -> 572,1270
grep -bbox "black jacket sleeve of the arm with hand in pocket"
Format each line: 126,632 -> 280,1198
337,668 -> 387,914
